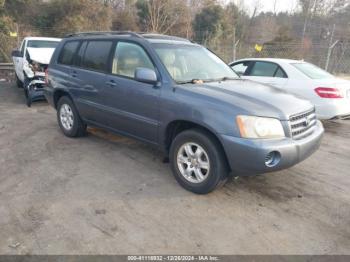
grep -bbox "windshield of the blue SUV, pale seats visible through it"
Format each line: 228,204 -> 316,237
153,44 -> 239,83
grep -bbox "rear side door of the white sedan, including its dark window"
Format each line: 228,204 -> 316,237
245,61 -> 288,89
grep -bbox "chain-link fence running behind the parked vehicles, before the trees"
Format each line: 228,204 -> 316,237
0,28 -> 350,75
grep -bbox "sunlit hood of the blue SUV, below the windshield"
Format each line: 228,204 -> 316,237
179,79 -> 314,120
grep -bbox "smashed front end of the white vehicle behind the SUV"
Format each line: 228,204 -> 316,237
23,48 -> 53,107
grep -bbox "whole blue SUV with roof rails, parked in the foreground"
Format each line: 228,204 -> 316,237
45,32 -> 324,194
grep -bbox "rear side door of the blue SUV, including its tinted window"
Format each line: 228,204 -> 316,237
70,40 -> 114,126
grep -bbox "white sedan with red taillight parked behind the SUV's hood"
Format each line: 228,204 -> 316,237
230,58 -> 350,119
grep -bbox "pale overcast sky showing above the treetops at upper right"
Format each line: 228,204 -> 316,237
233,0 -> 298,12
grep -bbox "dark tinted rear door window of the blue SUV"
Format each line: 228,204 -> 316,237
81,41 -> 113,72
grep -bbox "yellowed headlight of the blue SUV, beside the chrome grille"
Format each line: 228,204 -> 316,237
237,116 -> 285,138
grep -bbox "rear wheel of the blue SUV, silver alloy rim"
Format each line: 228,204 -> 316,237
57,96 -> 86,137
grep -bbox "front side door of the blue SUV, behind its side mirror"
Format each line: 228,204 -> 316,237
104,41 -> 160,144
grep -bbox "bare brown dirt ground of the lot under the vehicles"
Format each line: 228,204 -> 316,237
0,83 -> 350,254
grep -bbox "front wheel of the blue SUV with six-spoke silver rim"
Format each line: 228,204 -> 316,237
170,129 -> 228,194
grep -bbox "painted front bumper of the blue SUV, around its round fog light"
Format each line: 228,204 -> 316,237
221,121 -> 324,175
